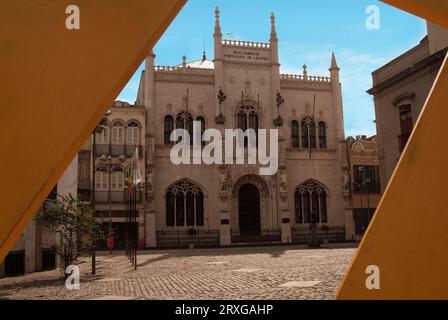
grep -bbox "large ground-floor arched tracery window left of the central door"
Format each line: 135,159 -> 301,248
166,180 -> 204,227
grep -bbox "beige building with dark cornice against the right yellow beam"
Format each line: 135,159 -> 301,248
368,23 -> 448,190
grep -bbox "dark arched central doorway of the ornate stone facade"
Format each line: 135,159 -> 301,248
238,183 -> 261,236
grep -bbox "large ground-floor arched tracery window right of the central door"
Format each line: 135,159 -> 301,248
295,181 -> 328,224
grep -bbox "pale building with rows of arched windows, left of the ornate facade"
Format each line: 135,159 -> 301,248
92,101 -> 146,249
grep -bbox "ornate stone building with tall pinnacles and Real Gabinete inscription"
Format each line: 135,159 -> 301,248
128,10 -> 352,248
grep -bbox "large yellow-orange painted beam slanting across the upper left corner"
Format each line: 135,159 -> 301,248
0,0 -> 186,262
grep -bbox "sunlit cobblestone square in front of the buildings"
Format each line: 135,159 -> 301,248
0,246 -> 355,300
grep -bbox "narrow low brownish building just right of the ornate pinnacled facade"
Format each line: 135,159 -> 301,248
347,136 -> 382,241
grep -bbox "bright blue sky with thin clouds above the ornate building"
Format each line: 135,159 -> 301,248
118,0 -> 426,136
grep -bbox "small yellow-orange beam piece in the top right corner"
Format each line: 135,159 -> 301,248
381,0 -> 448,28
